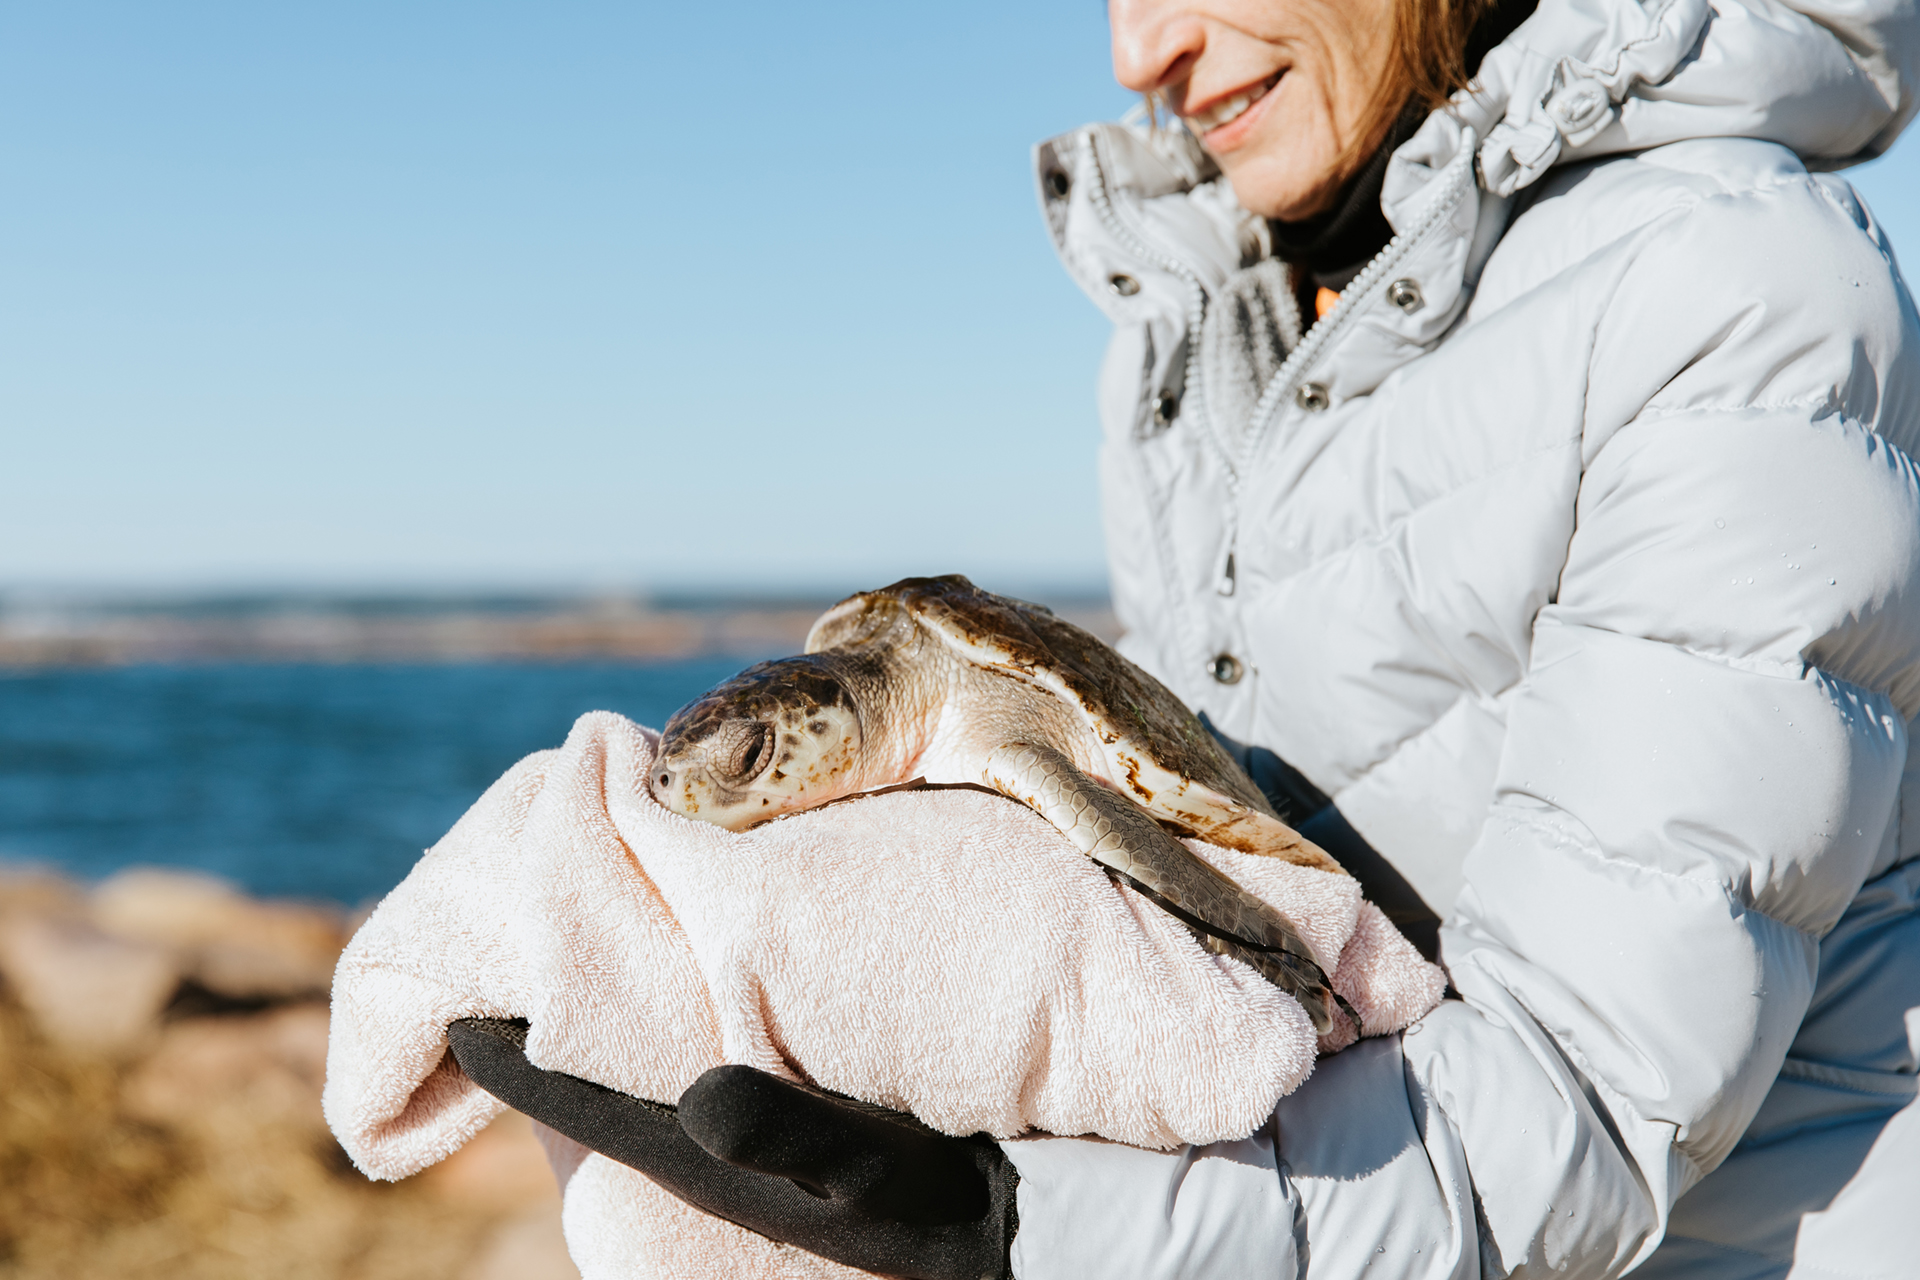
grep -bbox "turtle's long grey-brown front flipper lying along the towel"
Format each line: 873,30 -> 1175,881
987,743 -> 1338,1034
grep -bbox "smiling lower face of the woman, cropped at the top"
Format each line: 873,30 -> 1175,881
1108,0 -> 1392,221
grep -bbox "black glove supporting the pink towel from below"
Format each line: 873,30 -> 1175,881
447,1017 -> 1020,1280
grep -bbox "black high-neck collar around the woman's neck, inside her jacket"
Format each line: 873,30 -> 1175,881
1267,0 -> 1538,291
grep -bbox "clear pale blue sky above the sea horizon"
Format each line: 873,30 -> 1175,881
0,0 -> 1920,589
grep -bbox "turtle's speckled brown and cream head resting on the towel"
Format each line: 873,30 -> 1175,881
647,654 -> 864,831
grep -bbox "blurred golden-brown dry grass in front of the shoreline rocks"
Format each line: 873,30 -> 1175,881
0,994 -> 526,1280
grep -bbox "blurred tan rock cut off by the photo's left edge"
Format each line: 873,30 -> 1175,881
0,912 -> 180,1054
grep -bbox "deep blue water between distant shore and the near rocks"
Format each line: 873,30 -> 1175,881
0,658 -> 745,906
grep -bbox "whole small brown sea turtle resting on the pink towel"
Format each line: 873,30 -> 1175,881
647,574 -> 1340,1032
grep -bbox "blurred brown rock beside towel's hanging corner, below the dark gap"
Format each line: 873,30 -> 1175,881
121,1004 -> 326,1132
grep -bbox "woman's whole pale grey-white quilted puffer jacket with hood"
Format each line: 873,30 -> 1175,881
1012,0 -> 1920,1280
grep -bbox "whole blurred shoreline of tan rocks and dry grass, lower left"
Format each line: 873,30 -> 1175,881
0,869 -> 578,1280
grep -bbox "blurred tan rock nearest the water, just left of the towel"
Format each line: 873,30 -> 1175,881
90,867 -> 346,1000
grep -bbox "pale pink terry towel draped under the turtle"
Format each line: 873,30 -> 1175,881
324,712 -> 1444,1276
